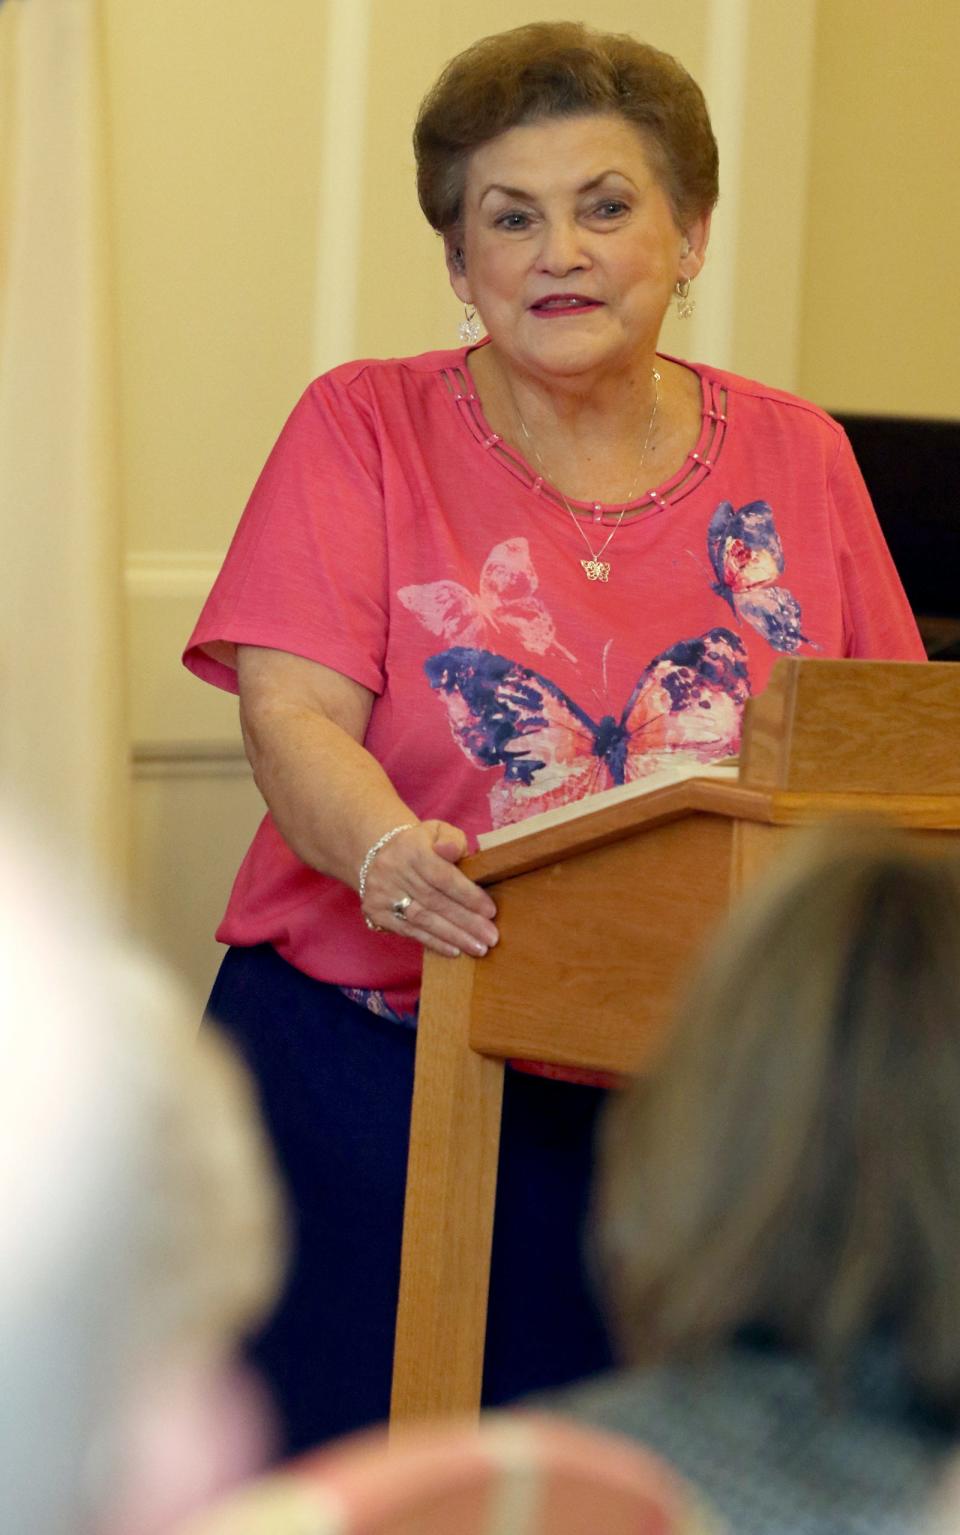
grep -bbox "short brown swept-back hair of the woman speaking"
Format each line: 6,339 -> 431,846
413,21 -> 717,235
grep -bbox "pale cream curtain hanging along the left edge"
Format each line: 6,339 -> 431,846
0,0 -> 127,887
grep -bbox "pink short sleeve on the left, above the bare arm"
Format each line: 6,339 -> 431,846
183,370 -> 387,694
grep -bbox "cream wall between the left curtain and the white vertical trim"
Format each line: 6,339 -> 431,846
103,0 -> 327,992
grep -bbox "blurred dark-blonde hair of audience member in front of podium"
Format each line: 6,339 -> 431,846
598,827 -> 960,1409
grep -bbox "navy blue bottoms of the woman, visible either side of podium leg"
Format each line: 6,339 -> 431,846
209,944 -> 611,1454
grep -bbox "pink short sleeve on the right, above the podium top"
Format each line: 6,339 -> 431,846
829,433 -> 926,662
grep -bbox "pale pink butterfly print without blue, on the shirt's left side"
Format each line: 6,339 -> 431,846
396,539 -> 576,662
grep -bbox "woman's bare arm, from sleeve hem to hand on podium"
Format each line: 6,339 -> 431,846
237,645 -> 498,956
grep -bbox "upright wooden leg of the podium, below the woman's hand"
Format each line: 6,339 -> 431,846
390,955 -> 504,1424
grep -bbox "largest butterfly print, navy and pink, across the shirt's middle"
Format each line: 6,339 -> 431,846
424,629 -> 750,826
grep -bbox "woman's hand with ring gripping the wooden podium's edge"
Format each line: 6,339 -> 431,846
357,821 -> 499,958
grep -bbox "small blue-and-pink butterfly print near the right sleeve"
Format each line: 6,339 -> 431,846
707,500 -> 809,651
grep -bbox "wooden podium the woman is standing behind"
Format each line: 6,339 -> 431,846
392,659 -> 960,1423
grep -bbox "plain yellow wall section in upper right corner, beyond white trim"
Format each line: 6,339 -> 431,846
792,0 -> 960,416
